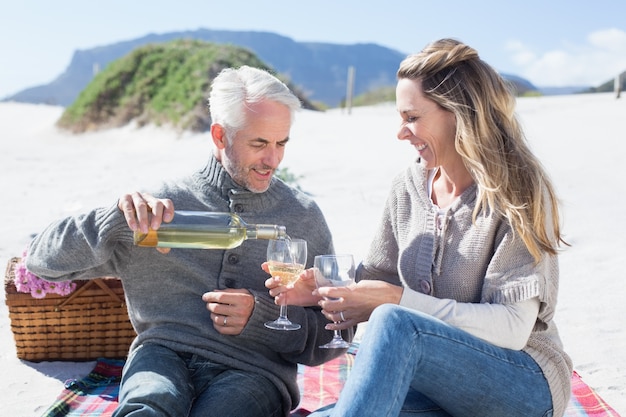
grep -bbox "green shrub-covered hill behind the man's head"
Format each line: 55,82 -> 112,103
57,40 -> 313,133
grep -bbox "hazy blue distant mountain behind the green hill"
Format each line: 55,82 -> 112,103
3,29 -> 552,107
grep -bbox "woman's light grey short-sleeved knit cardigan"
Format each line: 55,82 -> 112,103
357,163 -> 572,416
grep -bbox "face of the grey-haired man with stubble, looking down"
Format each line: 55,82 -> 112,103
212,100 -> 291,193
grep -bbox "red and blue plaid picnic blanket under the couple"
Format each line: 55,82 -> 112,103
42,352 -> 619,417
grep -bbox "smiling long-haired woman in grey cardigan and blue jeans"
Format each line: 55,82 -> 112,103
268,39 -> 572,417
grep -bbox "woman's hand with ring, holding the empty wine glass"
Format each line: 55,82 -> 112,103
313,280 -> 403,330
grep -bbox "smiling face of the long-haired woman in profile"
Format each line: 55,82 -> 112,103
396,78 -> 461,169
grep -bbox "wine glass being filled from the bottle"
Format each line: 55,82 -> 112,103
265,239 -> 306,330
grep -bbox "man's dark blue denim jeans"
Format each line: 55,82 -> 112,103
113,344 -> 285,417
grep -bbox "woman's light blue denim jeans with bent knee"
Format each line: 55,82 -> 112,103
309,304 -> 552,417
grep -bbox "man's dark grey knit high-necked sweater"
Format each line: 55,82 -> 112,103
27,157 -> 344,412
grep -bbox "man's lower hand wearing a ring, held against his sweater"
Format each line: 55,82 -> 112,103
202,289 -> 254,335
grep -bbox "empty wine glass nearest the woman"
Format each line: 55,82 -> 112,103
313,255 -> 354,349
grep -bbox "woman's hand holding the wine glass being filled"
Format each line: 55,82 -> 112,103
261,262 -> 320,307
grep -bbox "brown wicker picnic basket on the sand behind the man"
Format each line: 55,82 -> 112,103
4,258 -> 135,362
